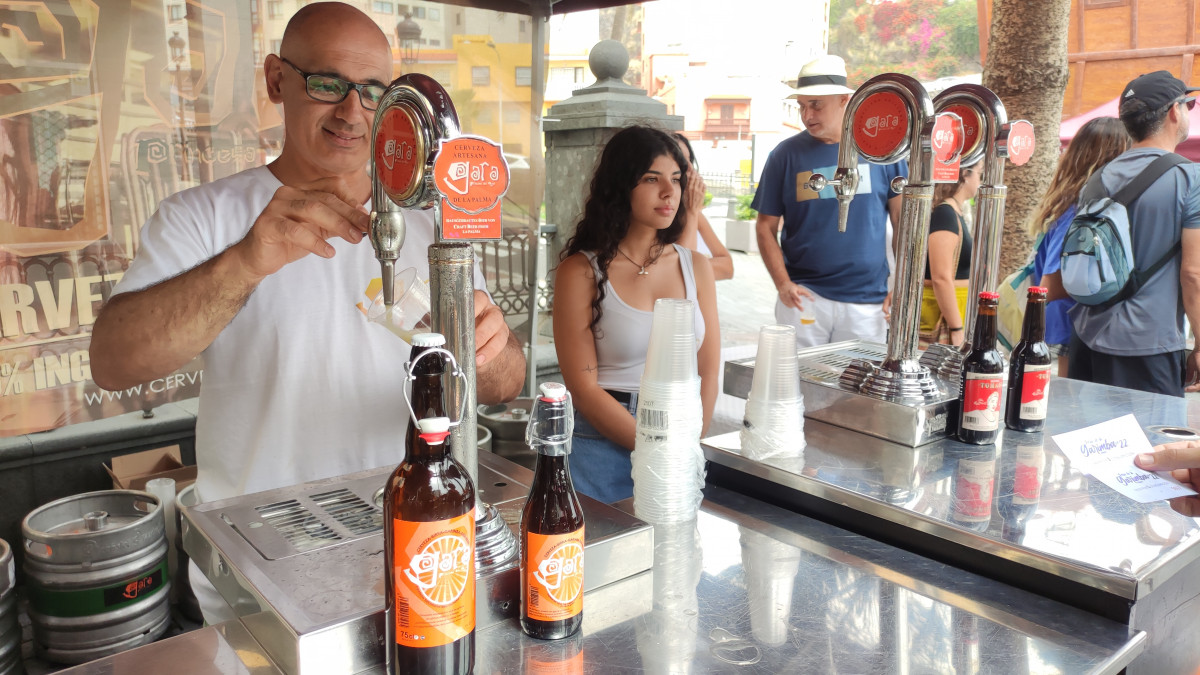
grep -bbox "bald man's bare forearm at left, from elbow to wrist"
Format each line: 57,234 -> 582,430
90,250 -> 262,389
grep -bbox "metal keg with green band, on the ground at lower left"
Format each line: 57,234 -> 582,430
20,490 -> 170,663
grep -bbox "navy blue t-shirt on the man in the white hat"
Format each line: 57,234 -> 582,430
751,131 -> 908,303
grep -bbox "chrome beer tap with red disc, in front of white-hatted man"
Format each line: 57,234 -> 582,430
806,73 -> 943,401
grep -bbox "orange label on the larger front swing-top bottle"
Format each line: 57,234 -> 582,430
391,509 -> 475,647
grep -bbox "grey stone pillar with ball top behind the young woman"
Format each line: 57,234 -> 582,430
542,40 -> 683,289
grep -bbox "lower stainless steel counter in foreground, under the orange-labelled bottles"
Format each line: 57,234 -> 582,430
58,486 -> 1145,675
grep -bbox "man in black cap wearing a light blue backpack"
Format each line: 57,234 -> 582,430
1058,71 -> 1200,396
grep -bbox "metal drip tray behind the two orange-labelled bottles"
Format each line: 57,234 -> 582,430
184,453 -> 654,674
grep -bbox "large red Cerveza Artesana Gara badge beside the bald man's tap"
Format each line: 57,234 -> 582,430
433,136 -> 509,239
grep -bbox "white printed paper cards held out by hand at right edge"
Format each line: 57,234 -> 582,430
1054,414 -> 1196,503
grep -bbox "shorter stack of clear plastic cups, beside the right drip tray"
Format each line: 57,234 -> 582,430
742,325 -> 805,460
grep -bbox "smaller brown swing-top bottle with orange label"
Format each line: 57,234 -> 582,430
521,382 -> 583,640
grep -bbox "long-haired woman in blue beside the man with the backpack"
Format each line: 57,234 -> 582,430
1030,118 -> 1130,377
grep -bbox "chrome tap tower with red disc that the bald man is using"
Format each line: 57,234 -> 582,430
370,73 -> 517,573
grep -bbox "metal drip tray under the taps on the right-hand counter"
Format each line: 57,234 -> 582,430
725,340 -> 959,448
